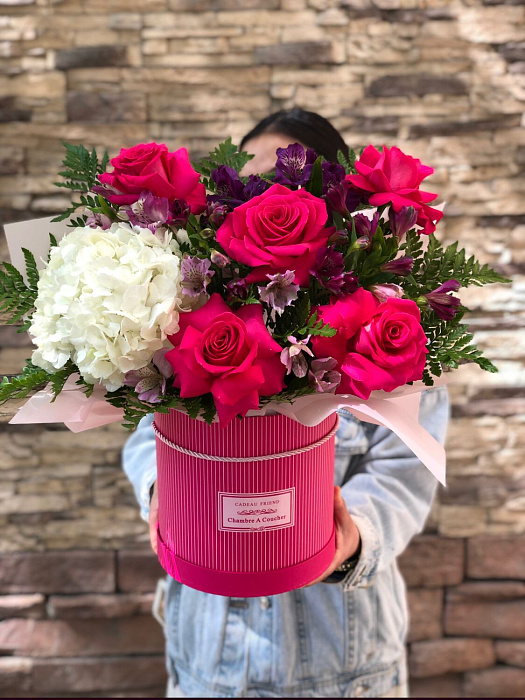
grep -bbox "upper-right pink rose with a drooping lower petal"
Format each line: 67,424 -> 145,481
346,146 -> 443,234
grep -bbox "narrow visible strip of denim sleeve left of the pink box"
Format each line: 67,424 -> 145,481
122,415 -> 157,521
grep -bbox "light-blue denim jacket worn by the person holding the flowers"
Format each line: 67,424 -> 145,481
124,388 -> 448,698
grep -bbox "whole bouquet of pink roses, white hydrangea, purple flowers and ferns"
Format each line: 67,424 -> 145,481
0,140 -> 506,426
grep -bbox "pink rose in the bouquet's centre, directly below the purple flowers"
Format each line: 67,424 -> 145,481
217,185 -> 333,286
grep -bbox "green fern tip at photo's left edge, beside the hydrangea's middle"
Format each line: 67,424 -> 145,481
0,248 -> 39,333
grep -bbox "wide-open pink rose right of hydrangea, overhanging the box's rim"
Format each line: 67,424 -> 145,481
166,294 -> 285,427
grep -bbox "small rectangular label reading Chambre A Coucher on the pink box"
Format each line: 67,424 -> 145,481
219,488 -> 295,532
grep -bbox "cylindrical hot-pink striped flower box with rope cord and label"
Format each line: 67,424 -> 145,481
154,410 -> 337,597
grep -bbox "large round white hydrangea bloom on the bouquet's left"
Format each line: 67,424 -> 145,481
29,222 -> 181,391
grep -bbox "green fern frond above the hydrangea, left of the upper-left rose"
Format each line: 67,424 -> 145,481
53,142 -> 111,226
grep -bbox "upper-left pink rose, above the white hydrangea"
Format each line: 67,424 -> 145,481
99,143 -> 206,214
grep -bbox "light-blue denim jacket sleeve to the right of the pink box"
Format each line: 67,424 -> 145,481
341,387 -> 449,590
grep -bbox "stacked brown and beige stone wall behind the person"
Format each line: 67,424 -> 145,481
0,0 -> 525,697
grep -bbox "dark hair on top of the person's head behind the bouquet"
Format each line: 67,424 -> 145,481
239,107 -> 348,163
